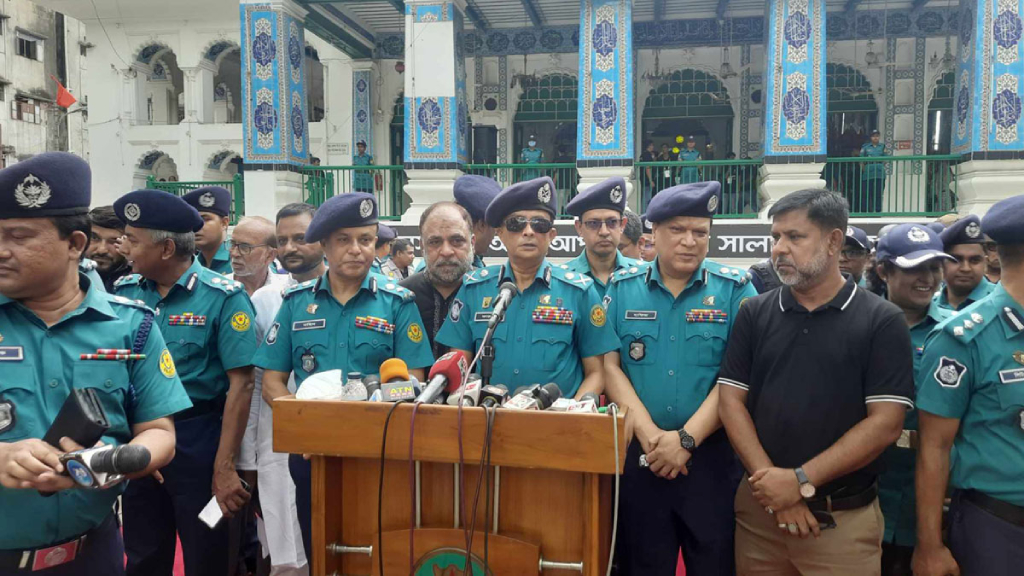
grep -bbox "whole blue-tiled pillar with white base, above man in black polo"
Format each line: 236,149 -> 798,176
760,0 -> 826,215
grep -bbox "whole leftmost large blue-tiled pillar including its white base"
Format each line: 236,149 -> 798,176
240,0 -> 309,219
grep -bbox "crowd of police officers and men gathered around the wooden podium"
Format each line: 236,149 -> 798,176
0,148 -> 1024,576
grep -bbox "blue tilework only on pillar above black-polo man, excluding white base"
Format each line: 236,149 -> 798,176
764,0 -> 825,156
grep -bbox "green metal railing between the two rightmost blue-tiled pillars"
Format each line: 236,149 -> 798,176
821,155 -> 961,216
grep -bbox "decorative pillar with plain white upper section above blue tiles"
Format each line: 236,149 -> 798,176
401,0 -> 469,223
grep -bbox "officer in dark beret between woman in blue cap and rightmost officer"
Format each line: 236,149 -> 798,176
935,214 -> 995,311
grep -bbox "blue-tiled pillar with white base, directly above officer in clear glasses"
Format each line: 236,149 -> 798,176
577,0 -> 636,194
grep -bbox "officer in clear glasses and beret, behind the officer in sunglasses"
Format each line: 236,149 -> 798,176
562,176 -> 637,296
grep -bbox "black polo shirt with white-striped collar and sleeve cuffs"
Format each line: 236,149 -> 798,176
718,277 -> 914,496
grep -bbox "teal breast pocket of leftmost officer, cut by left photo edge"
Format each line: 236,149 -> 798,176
0,361 -> 38,442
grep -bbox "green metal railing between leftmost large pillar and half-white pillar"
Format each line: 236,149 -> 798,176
302,166 -> 409,220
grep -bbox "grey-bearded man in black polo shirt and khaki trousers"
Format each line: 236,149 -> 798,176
718,190 -> 914,576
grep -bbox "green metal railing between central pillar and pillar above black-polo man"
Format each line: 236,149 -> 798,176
633,159 -> 762,218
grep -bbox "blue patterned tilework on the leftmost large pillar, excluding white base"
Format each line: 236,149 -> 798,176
240,4 -> 309,164
